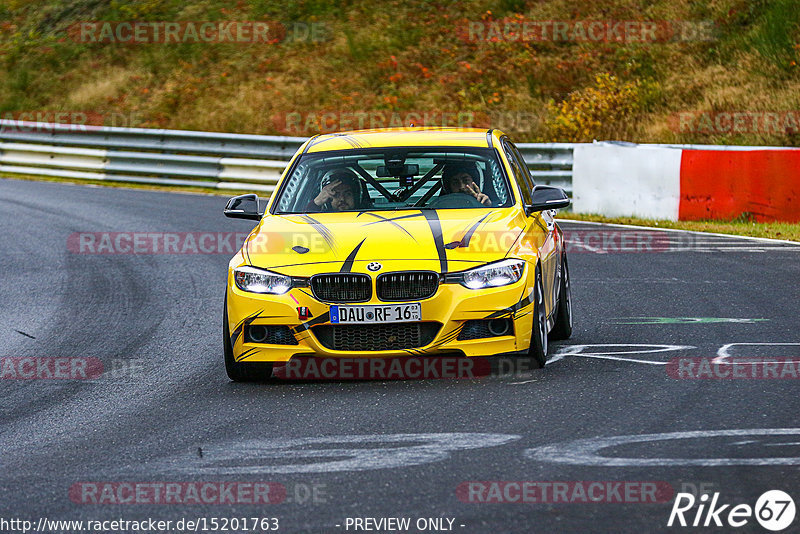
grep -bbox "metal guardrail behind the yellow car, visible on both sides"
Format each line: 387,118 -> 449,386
0,120 -> 575,193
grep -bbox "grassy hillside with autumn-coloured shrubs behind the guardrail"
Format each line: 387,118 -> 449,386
0,0 -> 800,146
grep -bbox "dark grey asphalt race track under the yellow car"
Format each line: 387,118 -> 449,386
0,180 -> 800,533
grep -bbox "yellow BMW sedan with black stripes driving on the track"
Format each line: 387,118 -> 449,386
223,128 -> 572,381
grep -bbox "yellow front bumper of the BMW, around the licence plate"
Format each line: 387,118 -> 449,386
227,268 -> 534,362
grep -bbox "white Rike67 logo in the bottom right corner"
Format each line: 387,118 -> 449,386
667,490 -> 796,532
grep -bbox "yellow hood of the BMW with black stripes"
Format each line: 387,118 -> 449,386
244,208 -> 526,276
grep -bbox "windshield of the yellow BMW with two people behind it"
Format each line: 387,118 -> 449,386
274,148 -> 513,214
